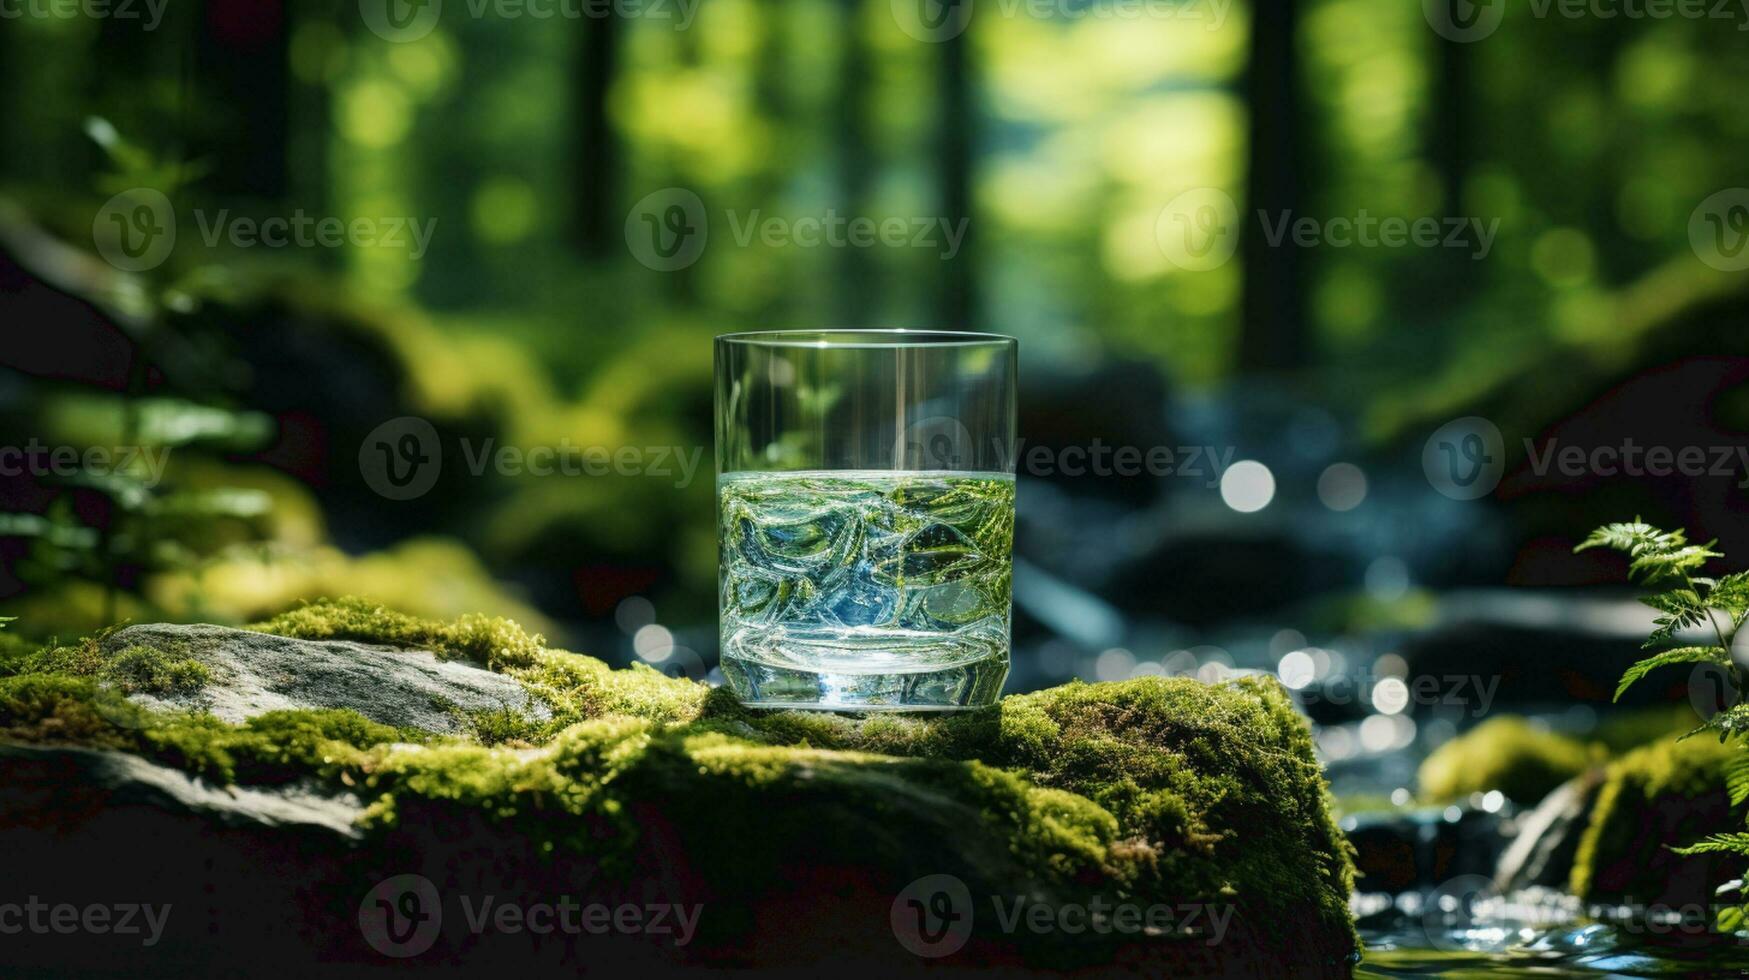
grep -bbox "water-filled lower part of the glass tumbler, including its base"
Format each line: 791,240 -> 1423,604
717,471 -> 1014,711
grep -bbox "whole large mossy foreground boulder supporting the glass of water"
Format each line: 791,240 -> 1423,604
0,602 -> 1357,975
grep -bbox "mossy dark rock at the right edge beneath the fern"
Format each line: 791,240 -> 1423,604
1571,739 -> 1744,903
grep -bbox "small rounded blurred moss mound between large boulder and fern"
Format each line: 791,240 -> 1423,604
1417,714 -> 1602,807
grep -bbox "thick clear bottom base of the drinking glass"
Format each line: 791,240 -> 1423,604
722,656 -> 1007,712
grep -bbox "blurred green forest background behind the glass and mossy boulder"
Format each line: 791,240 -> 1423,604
0,0 -> 1749,735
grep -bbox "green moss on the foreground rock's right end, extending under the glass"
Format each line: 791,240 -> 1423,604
678,677 -> 1354,949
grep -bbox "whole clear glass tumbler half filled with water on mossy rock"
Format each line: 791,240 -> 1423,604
715,331 -> 1018,711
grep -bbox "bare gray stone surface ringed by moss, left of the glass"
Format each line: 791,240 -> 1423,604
103,623 -> 553,733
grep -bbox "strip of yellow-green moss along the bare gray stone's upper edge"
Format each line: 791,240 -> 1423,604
250,597 -> 546,670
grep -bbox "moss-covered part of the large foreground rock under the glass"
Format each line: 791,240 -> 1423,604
0,602 -> 1357,975
